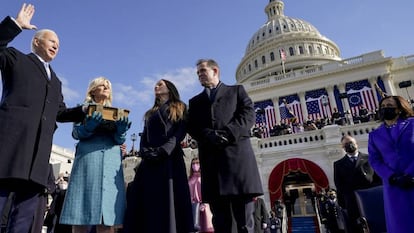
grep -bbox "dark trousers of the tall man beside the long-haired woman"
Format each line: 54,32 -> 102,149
209,197 -> 254,233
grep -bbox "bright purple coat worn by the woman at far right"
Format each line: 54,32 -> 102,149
368,118 -> 414,233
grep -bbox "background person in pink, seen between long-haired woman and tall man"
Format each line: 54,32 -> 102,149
188,157 -> 214,233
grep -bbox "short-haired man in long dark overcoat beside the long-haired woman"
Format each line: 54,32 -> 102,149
188,59 -> 263,233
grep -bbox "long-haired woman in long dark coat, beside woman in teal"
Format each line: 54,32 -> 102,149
124,79 -> 194,233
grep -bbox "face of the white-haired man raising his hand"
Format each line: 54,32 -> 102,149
34,32 -> 59,62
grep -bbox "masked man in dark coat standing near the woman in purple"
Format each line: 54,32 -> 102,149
333,135 -> 381,233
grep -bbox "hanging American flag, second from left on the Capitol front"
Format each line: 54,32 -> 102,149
279,94 -> 303,123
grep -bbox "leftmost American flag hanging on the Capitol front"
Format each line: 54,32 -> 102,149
254,100 -> 276,138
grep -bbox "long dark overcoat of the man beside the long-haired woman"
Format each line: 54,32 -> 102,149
188,84 -> 263,202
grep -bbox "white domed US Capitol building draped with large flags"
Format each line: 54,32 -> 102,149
51,0 -> 414,216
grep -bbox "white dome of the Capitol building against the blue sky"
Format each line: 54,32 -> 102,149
236,0 -> 341,83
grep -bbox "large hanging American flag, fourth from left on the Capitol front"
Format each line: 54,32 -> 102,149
346,80 -> 377,115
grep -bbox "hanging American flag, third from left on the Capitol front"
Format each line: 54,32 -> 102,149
305,89 -> 332,120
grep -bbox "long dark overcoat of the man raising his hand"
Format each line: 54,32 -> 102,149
0,17 -> 84,188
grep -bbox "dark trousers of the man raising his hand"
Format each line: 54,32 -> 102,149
0,188 -> 39,233
